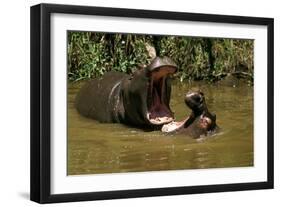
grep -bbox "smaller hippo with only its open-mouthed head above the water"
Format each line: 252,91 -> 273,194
162,90 -> 218,138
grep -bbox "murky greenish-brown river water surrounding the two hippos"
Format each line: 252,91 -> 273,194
67,79 -> 254,175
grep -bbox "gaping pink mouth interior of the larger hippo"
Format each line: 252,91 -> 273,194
147,67 -> 176,125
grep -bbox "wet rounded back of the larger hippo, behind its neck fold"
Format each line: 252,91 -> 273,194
76,71 -> 126,122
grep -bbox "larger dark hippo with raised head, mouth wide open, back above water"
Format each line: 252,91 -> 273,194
76,57 -> 177,127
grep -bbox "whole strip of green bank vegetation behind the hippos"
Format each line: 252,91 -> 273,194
67,31 -> 254,84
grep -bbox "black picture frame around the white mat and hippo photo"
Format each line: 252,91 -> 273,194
30,4 -> 274,203
